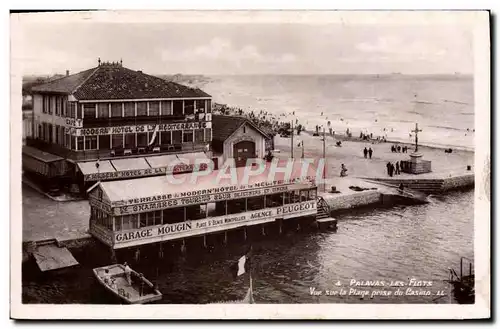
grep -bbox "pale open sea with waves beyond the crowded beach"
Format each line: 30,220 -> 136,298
198,74 -> 475,150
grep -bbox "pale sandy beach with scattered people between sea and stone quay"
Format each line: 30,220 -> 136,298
274,133 -> 474,178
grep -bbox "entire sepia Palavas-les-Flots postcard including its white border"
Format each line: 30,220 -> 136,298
10,10 -> 491,319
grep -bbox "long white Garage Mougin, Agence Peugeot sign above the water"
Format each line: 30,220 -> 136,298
113,200 -> 316,248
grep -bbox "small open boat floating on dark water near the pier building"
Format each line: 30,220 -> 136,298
93,264 -> 162,304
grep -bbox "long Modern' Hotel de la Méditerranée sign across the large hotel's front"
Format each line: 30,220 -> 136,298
68,122 -> 212,136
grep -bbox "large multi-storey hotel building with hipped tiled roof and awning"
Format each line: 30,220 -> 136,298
23,60 -> 212,192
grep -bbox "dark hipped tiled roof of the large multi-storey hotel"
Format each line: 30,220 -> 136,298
33,65 -> 211,100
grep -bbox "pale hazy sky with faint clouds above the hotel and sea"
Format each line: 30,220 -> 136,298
16,13 -> 473,75
